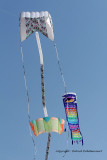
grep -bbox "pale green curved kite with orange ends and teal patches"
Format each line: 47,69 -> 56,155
30,117 -> 65,136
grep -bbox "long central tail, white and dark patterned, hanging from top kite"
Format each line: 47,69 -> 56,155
35,32 -> 51,160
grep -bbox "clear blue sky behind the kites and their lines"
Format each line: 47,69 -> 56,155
0,0 -> 107,160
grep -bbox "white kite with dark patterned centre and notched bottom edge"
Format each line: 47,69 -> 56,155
20,11 -> 54,42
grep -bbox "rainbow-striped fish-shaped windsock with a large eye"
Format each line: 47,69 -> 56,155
63,93 -> 83,145
